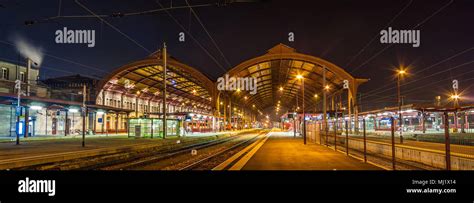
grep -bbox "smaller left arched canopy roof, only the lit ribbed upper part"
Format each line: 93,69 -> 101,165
97,51 -> 215,110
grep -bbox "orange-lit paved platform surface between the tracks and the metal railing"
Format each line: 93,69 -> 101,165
242,132 -> 382,170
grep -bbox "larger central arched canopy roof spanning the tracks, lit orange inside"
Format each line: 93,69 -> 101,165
228,44 -> 367,113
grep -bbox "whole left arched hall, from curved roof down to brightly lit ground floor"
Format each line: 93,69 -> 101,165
96,51 -> 219,137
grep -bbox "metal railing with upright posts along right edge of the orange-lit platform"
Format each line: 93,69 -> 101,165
307,116 -> 474,170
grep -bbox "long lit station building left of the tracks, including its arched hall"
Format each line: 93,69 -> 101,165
0,51 -> 223,137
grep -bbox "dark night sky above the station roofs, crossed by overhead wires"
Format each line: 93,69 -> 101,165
0,0 -> 474,110
